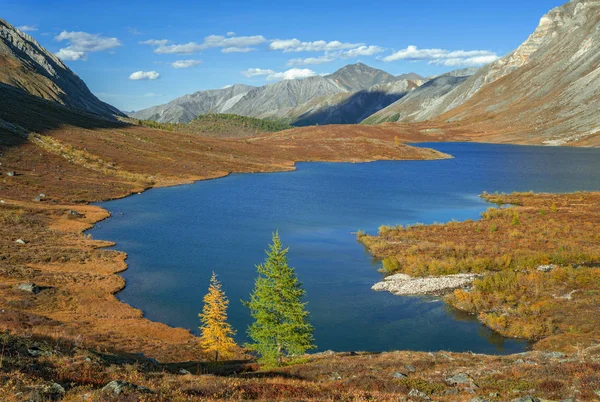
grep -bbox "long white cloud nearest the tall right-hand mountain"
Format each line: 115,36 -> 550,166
381,46 -> 498,66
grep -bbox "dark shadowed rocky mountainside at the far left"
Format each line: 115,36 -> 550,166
0,19 -> 122,119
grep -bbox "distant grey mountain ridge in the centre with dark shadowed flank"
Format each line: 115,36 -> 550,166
131,63 -> 423,125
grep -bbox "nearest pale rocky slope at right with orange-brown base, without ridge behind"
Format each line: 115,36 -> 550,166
440,0 -> 600,145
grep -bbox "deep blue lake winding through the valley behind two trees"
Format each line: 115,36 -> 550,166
91,143 -> 600,354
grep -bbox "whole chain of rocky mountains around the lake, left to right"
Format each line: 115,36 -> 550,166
0,0 -> 600,145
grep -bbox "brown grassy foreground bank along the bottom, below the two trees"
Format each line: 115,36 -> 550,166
0,334 -> 600,401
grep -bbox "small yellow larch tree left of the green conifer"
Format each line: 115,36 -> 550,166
199,272 -> 237,361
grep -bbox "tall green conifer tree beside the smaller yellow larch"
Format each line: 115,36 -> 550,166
244,233 -> 315,366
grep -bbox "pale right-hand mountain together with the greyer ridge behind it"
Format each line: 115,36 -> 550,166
365,0 -> 600,145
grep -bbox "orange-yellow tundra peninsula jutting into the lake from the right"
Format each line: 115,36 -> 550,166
359,193 -> 600,352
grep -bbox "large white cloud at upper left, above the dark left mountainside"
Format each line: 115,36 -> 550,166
54,31 -> 122,60
